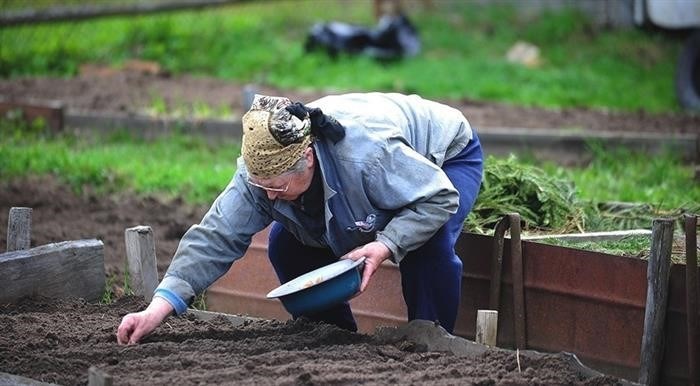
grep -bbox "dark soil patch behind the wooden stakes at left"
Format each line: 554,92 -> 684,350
0,177 -> 207,284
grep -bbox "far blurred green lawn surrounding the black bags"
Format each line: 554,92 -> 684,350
0,0 -> 682,112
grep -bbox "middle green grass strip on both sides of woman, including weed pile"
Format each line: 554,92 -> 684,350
0,119 -> 700,230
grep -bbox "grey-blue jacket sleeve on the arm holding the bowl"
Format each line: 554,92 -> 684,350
366,143 -> 459,263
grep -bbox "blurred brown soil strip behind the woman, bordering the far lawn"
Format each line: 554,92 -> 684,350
0,69 -> 700,133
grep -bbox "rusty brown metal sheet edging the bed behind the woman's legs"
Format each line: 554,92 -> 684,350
207,231 -> 688,385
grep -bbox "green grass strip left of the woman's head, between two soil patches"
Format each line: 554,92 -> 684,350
0,119 -> 240,204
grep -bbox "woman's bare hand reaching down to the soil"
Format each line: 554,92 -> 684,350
117,296 -> 173,344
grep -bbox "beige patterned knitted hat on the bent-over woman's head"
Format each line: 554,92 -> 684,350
241,95 -> 311,178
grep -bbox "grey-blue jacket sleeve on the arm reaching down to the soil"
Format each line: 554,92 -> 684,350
154,167 -> 271,315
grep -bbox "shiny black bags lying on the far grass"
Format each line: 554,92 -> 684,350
304,14 -> 421,60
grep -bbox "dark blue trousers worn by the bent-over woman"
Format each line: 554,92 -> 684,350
268,133 -> 483,333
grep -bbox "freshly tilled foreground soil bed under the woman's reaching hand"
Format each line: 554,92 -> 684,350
0,297 -> 619,385
